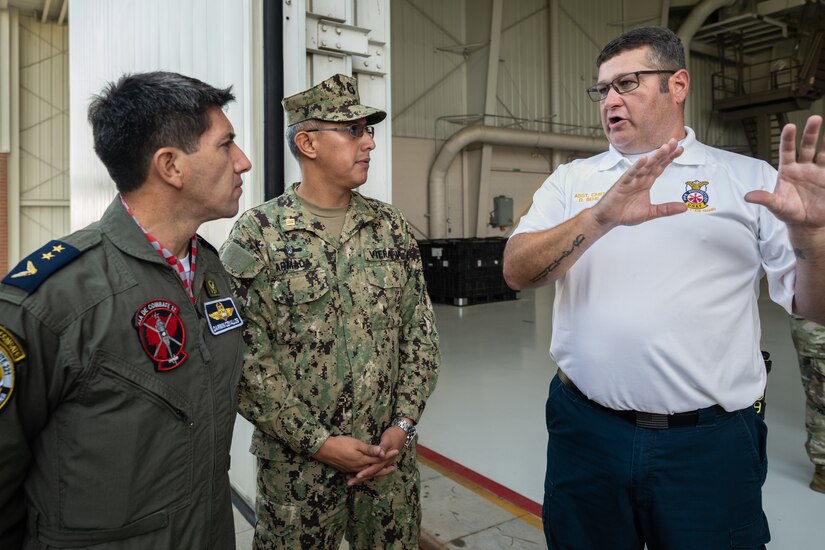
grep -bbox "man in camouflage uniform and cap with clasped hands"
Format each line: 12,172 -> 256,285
221,75 -> 440,550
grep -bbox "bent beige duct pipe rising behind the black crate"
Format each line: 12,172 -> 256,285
428,126 -> 608,239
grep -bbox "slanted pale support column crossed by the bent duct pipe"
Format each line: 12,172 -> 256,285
474,0 -> 502,237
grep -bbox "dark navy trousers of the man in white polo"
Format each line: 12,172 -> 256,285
542,376 -> 770,550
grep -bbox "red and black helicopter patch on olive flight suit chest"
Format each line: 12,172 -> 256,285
134,298 -> 188,372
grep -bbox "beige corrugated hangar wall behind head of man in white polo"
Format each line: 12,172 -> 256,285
392,0 -> 746,149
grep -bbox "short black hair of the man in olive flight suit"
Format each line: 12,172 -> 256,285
89,72 -> 235,193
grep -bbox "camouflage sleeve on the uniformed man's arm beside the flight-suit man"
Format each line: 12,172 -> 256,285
221,215 -> 330,455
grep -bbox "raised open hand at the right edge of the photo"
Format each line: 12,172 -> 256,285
745,115 -> 825,229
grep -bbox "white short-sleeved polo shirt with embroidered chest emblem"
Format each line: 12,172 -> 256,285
513,128 -> 795,414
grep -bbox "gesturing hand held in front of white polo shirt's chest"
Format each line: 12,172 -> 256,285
592,139 -> 687,233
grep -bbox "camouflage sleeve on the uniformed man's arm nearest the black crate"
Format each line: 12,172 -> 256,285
394,220 -> 441,423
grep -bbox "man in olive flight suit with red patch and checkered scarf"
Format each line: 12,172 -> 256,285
0,73 -> 250,550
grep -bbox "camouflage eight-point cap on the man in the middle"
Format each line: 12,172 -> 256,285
281,74 -> 387,126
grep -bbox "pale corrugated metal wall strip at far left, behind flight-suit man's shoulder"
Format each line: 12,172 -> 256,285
18,17 -> 69,257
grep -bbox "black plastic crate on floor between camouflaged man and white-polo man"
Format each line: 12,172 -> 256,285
419,237 -> 518,306
